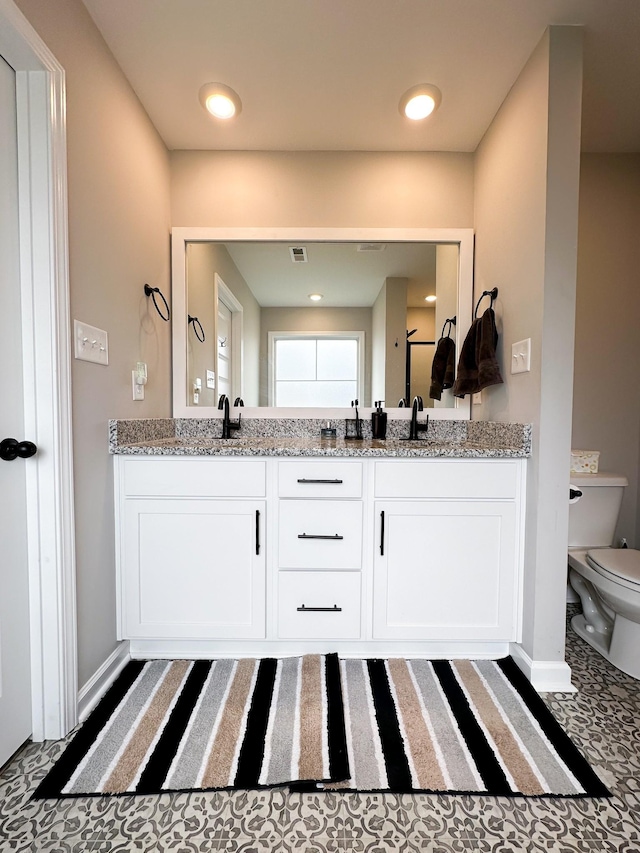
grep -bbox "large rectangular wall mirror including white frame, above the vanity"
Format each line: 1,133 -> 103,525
172,228 -> 473,418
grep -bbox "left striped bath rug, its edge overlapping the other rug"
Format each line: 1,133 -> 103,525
34,654 -> 348,799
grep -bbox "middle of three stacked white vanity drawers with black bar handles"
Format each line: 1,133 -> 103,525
278,501 -> 362,569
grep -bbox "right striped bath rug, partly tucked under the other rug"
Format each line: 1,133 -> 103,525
337,658 -> 609,797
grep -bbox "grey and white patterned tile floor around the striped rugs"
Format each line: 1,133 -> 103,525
0,611 -> 640,853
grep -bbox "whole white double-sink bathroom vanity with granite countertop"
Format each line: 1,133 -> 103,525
111,421 -> 530,657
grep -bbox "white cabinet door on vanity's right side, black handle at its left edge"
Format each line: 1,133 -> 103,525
373,501 -> 519,641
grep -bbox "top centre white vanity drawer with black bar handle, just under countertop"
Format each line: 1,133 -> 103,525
278,459 -> 362,498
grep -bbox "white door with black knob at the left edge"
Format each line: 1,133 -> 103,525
0,57 -> 31,766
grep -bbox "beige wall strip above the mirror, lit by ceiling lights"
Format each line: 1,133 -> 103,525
171,151 -> 473,228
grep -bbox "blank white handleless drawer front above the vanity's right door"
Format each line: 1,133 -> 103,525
374,459 -> 519,500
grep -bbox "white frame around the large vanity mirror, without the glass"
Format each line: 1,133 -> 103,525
171,227 -> 473,420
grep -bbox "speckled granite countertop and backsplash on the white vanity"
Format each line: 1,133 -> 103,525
109,418 -> 531,459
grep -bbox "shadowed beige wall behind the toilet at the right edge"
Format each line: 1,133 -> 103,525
572,154 -> 640,547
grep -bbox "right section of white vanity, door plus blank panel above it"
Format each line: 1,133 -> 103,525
373,460 -> 523,641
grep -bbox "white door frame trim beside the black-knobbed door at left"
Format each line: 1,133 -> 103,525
0,0 -> 78,741
